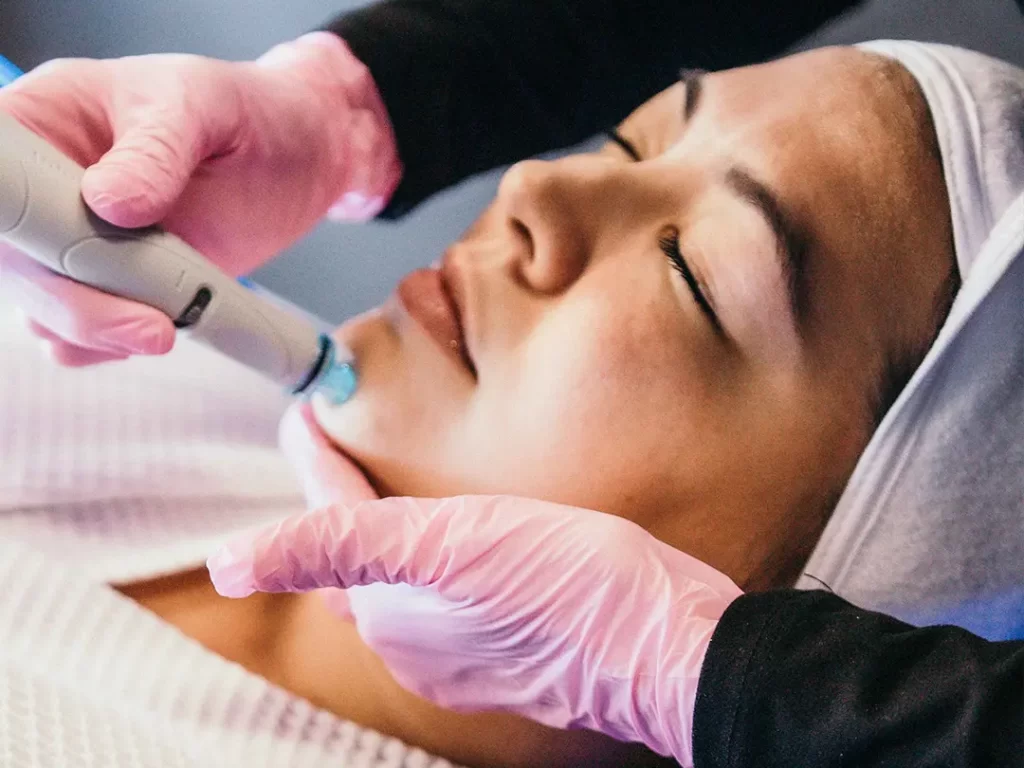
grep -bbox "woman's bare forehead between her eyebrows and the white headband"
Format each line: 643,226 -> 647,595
708,54 -> 927,250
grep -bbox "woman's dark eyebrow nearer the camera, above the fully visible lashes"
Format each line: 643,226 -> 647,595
726,167 -> 807,333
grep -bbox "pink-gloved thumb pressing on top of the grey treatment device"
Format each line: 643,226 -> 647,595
82,112 -> 201,228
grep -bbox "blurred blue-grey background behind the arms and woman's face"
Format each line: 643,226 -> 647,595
0,0 -> 1024,321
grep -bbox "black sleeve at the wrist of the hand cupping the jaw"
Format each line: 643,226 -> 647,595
693,591 -> 1024,768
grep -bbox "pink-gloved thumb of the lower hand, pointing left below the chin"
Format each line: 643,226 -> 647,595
207,498 -> 462,597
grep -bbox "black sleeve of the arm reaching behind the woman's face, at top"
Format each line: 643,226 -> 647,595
327,0 -> 860,216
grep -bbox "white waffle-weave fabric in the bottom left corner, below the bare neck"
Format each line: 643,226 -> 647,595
0,541 -> 451,768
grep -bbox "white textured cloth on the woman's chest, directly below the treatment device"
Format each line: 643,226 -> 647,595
0,305 -> 305,583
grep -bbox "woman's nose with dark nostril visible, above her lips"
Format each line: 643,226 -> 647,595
496,157 -> 615,294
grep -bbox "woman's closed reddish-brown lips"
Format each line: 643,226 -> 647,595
395,267 -> 476,378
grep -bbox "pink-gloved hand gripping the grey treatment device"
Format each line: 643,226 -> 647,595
0,37 -> 401,365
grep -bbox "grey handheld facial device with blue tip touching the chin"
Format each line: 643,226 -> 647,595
0,57 -> 357,404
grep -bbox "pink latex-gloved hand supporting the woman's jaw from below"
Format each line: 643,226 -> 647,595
209,411 -> 740,766
